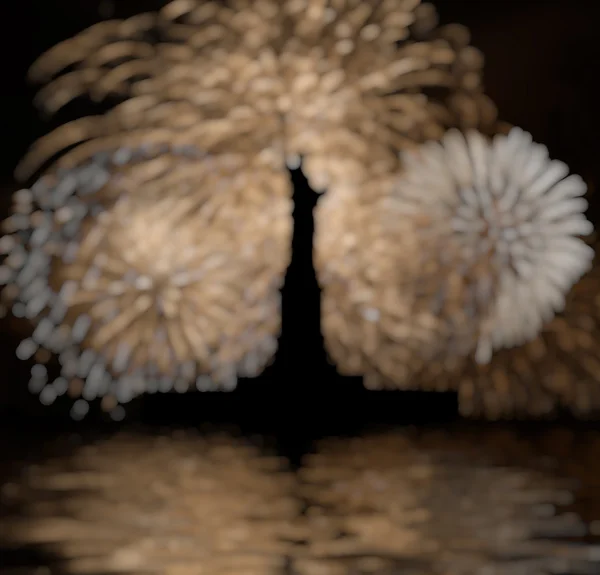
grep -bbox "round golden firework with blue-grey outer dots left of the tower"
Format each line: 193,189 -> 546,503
0,147 -> 291,416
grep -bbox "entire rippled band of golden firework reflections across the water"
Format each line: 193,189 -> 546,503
0,427 -> 600,575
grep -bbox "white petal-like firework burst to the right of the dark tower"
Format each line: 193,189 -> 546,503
388,128 -> 594,363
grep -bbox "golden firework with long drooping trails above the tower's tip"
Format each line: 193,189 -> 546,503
22,0 -> 494,190
